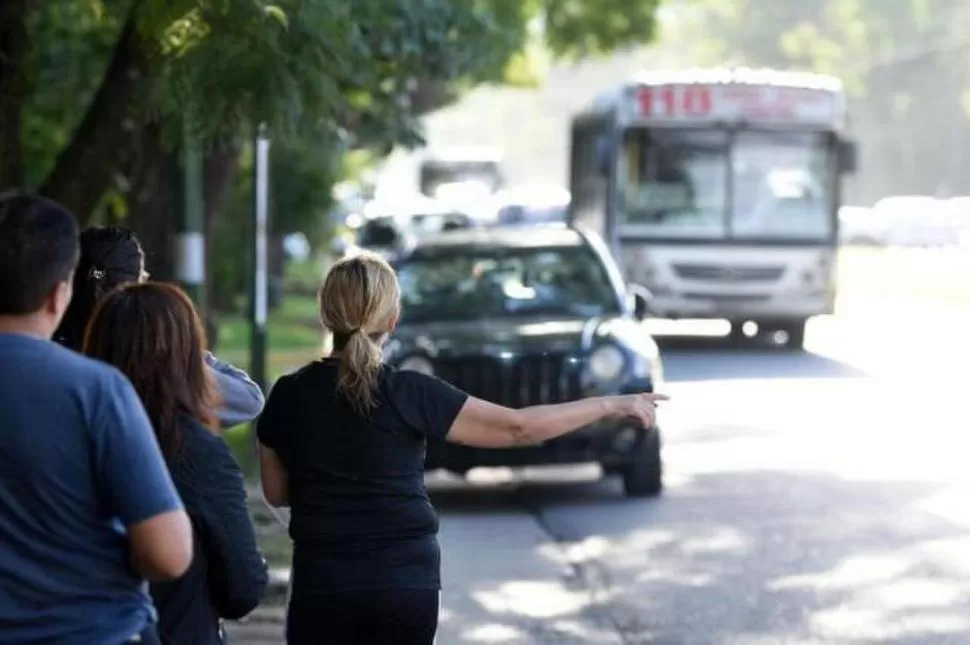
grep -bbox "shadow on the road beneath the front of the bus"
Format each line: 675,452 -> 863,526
656,336 -> 869,382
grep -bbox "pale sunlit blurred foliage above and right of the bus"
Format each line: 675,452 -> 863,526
682,0 -> 970,202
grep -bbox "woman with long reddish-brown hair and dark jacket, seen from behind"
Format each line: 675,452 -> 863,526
84,283 -> 269,645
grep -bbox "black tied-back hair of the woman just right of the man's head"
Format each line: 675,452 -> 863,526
54,226 -> 145,351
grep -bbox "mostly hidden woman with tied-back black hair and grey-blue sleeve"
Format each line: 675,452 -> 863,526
54,226 -> 265,428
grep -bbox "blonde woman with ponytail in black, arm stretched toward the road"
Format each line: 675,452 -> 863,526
257,254 -> 667,645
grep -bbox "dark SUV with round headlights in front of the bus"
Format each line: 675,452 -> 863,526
385,226 -> 663,496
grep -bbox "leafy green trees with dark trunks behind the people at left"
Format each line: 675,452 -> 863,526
0,0 -> 659,312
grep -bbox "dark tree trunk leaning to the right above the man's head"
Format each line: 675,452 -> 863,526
38,15 -> 146,224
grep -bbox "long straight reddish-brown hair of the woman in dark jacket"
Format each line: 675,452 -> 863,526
84,282 -> 217,461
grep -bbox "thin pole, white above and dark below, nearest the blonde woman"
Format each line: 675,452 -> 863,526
250,124 -> 269,389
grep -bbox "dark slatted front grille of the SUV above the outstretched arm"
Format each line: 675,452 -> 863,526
435,354 -> 582,408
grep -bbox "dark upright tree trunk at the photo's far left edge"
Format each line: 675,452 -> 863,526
0,0 -> 29,193
